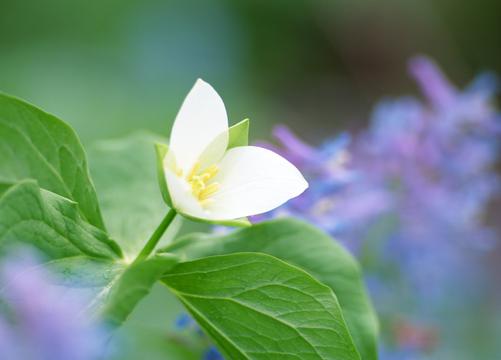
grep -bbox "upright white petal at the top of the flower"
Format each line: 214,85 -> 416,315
169,79 -> 228,174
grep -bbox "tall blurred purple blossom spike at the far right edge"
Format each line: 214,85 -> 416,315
360,57 -> 499,296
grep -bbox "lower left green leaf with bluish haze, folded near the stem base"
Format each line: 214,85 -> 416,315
0,180 -> 177,325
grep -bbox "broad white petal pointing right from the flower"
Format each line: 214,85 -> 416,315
207,146 -> 308,220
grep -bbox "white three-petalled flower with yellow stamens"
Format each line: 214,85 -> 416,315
163,79 -> 308,221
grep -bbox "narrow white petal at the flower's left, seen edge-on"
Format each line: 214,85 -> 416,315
164,167 -> 205,217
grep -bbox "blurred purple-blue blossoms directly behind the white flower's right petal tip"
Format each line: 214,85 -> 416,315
251,125 -> 390,248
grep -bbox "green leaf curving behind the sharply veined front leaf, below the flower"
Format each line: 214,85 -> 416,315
165,219 -> 378,360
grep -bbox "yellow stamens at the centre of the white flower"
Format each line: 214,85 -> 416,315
186,162 -> 219,206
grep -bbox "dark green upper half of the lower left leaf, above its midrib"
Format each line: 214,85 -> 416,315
0,180 -> 121,259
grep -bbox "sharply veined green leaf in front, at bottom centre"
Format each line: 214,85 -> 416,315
162,253 -> 360,360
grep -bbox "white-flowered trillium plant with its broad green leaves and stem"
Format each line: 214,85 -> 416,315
0,80 -> 378,360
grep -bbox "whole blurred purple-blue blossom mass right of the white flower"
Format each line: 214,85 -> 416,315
254,57 -> 501,358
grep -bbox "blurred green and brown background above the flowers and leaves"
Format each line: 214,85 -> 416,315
0,0 -> 501,359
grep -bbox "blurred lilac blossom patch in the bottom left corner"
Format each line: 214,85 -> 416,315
0,252 -> 104,360
